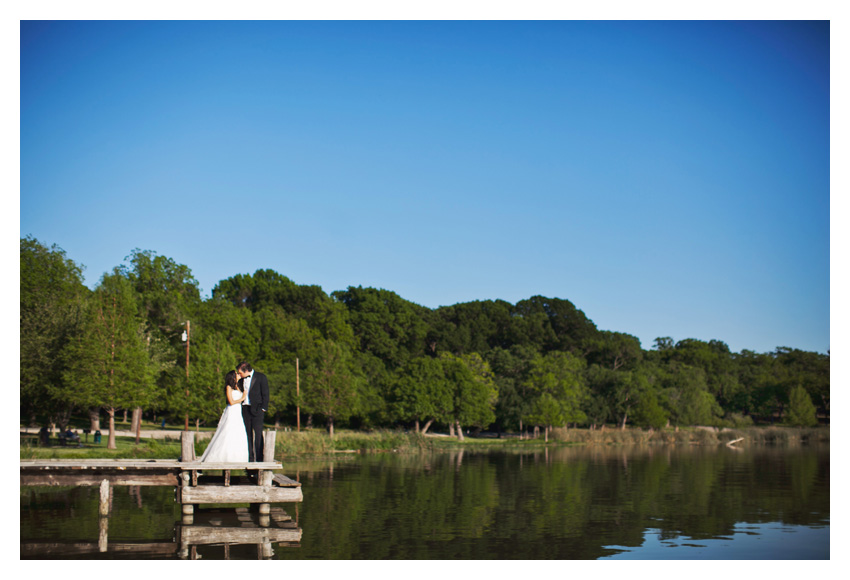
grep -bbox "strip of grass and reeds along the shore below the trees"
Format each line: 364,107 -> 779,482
20,426 -> 829,459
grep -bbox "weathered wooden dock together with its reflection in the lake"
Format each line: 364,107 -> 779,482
21,431 -> 303,560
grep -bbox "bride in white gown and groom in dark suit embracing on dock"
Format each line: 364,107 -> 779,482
201,362 -> 269,463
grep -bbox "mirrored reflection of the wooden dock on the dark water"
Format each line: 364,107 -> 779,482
21,507 -> 301,560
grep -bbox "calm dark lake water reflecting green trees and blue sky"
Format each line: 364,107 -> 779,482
20,445 -> 830,560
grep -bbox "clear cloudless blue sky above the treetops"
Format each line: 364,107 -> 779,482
20,21 -> 830,352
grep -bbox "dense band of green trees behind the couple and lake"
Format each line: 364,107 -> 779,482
20,236 -> 829,444
